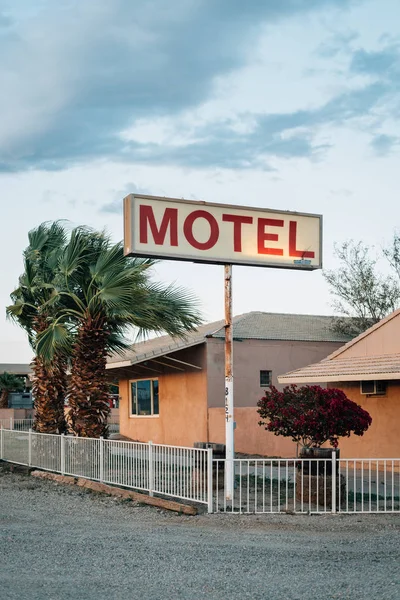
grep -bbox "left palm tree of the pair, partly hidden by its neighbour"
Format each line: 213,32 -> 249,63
6,222 -> 67,433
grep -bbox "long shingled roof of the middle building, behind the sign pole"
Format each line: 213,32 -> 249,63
107,312 -> 349,369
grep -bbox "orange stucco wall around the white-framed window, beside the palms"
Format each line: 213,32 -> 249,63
119,371 -> 207,446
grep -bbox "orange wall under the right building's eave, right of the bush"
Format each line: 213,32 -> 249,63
329,382 -> 400,458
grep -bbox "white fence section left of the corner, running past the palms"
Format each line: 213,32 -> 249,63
0,428 -> 212,506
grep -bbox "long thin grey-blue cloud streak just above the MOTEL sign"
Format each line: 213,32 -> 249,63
115,82 -> 389,170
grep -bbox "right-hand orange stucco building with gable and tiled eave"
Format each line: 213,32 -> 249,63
279,310 -> 400,458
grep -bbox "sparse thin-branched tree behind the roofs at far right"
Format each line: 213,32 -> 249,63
323,240 -> 400,336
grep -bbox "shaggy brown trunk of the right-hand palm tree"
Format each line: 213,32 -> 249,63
68,317 -> 110,438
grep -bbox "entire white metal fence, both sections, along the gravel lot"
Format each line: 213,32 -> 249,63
0,428 -> 400,514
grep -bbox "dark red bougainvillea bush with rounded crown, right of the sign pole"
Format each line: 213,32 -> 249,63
257,385 -> 372,448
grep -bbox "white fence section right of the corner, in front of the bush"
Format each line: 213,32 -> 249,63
213,452 -> 400,514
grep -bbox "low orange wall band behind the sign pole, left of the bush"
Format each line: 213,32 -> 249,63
208,407 -> 296,458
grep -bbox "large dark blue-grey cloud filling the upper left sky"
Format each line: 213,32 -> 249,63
0,0 -> 351,172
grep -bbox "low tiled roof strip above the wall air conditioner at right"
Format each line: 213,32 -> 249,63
278,353 -> 400,383
